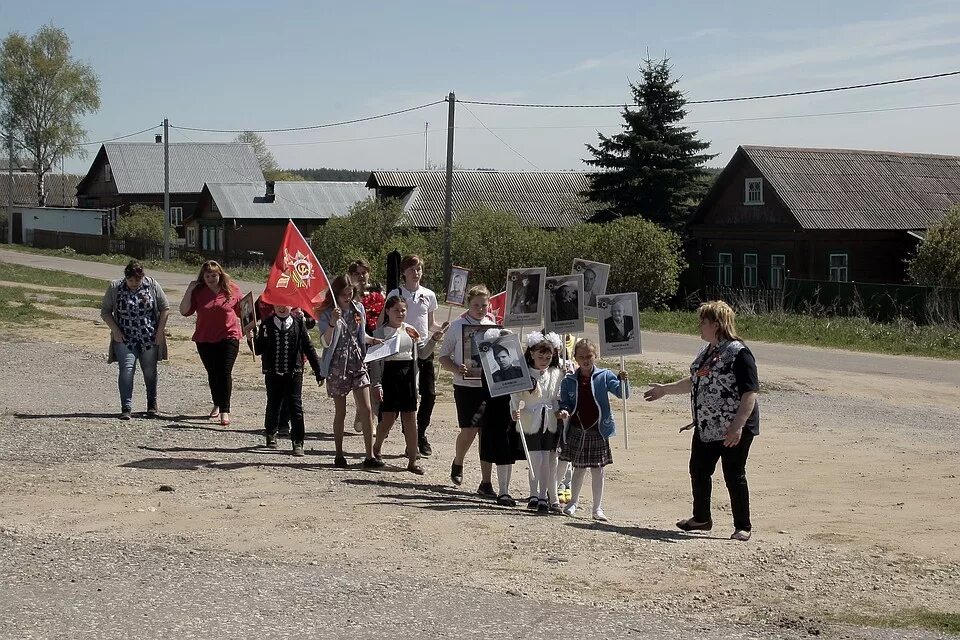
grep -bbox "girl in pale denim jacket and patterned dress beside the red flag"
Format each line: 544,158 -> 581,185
317,276 -> 383,469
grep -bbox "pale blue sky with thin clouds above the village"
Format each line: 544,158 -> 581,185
0,0 -> 960,173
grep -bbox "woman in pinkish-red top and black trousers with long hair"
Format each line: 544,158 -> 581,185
180,260 -> 243,426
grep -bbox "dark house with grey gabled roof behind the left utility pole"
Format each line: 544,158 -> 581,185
77,142 -> 263,237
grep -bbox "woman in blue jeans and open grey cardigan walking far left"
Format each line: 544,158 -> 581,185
100,260 -> 170,420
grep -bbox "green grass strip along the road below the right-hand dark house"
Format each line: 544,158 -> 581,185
640,311 -> 960,359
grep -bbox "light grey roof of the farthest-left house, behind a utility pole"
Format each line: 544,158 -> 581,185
88,142 -> 263,193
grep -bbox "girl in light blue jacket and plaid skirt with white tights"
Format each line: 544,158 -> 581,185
558,338 -> 630,522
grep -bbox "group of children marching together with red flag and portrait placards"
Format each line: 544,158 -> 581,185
246,256 -> 629,521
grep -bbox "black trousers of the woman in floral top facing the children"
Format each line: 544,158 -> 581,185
690,429 -> 753,531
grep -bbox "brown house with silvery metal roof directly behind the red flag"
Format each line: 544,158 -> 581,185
184,180 -> 371,262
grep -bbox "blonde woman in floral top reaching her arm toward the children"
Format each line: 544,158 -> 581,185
643,300 -> 760,542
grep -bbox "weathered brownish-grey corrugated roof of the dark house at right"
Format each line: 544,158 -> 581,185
740,145 -> 960,230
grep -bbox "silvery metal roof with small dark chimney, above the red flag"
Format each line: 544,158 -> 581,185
206,181 -> 372,220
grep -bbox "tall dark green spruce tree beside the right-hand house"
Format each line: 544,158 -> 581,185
584,59 -> 716,230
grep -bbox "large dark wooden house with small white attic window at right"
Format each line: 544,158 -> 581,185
688,146 -> 960,289
